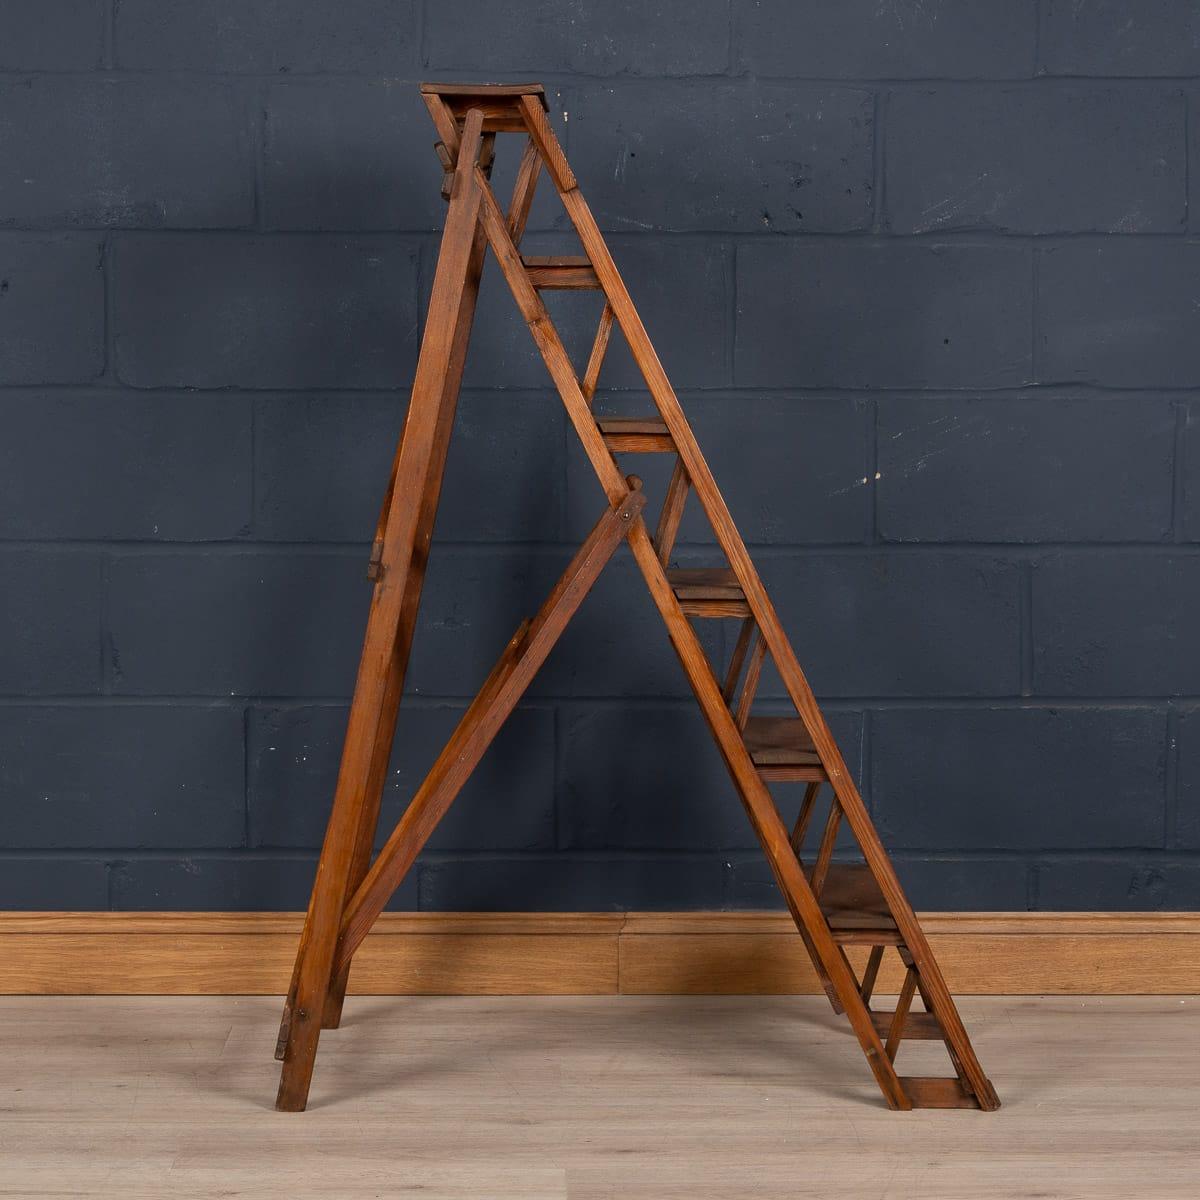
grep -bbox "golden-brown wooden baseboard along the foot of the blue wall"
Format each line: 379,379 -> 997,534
0,912 -> 1200,995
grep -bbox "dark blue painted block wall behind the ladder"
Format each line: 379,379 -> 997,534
0,0 -> 1200,908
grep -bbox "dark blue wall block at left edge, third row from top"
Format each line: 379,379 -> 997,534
0,233 -> 104,384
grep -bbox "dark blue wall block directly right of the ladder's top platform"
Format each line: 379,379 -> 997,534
564,83 -> 875,233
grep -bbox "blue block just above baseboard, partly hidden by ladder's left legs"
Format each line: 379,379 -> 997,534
113,853 -> 416,912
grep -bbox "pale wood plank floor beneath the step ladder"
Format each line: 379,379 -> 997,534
0,996 -> 1200,1200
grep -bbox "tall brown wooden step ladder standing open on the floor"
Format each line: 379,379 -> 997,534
276,84 -> 1000,1111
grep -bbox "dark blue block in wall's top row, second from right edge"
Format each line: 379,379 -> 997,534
734,0 -> 1038,79
